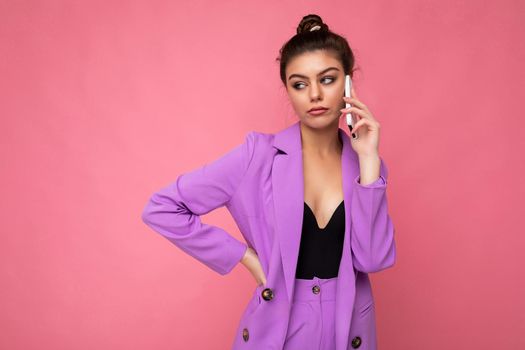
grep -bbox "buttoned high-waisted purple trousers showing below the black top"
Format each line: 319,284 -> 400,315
283,277 -> 337,350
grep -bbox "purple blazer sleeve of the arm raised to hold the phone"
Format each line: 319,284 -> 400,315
351,157 -> 396,273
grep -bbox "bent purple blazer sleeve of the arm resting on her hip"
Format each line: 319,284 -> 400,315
138,131 -> 255,275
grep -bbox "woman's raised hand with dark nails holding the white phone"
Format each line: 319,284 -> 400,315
341,87 -> 380,156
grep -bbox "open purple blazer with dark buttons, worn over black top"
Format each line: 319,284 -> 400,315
142,121 -> 396,350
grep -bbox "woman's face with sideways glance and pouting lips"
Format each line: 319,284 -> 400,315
286,50 -> 345,128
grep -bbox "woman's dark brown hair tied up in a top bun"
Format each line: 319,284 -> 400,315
276,14 -> 356,86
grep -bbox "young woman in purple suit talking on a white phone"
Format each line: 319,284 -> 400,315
142,15 -> 396,350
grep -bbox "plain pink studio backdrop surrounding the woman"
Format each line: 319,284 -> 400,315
0,0 -> 525,350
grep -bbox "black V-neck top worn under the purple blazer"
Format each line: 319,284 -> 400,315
295,200 -> 345,279
